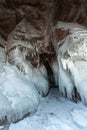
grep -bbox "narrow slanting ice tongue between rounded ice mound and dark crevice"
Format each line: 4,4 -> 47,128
7,47 -> 49,96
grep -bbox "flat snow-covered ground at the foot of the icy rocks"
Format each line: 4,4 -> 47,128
9,89 -> 87,130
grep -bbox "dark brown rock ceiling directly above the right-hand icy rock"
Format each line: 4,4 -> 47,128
54,0 -> 87,25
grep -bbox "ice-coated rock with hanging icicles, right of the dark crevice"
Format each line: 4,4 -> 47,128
58,22 -> 87,104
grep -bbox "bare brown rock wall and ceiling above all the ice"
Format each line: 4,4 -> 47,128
0,0 -> 87,66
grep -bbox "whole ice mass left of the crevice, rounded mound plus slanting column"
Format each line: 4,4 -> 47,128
0,23 -> 49,125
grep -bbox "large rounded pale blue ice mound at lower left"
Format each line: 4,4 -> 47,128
0,63 -> 40,125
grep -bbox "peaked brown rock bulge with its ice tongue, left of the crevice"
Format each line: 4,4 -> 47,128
7,19 -> 49,96
